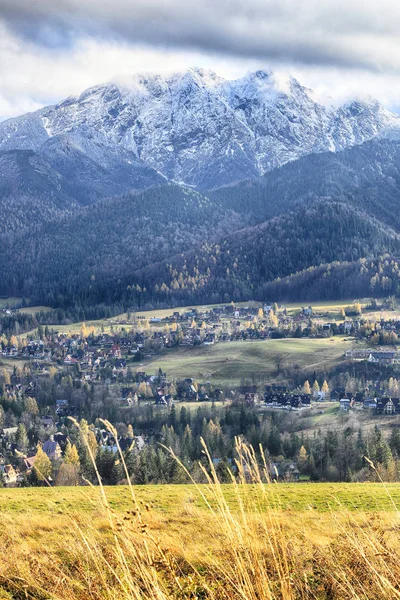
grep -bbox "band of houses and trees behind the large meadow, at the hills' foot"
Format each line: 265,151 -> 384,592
0,302 -> 400,372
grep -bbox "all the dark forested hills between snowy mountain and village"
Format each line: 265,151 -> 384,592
0,137 -> 400,308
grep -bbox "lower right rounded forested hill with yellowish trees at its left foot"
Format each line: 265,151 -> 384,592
132,200 -> 400,303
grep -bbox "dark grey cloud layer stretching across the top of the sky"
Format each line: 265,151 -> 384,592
0,0 -> 400,72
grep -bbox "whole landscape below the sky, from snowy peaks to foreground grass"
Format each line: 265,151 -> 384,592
0,69 -> 400,600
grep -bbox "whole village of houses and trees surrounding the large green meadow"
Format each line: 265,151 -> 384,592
0,305 -> 400,486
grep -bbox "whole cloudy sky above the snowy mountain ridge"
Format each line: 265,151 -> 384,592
0,0 -> 400,120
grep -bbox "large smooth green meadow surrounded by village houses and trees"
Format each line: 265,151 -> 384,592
144,336 -> 354,386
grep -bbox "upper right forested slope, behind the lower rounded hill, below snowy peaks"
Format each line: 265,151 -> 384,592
210,139 -> 400,228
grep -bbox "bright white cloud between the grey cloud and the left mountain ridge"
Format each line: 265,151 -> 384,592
0,23 -> 258,121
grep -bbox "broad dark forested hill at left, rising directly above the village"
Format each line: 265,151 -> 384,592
0,184 -> 240,306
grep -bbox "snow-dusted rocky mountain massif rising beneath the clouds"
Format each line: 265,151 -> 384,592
0,69 -> 400,189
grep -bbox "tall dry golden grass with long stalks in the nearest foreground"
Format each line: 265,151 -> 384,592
0,421 -> 400,600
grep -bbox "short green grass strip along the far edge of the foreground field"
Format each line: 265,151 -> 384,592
0,483 -> 400,515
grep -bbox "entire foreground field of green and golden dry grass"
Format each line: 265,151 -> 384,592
0,476 -> 400,600
